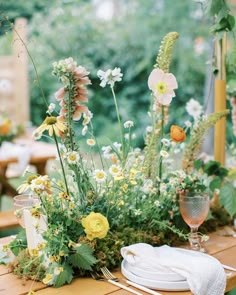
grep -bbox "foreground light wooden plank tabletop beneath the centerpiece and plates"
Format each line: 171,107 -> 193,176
0,233 -> 236,295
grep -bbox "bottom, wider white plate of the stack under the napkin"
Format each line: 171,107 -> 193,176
121,260 -> 189,291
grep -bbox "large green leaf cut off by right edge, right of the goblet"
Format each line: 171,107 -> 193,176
220,182 -> 236,216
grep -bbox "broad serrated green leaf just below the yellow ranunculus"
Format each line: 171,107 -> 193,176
69,244 -> 97,270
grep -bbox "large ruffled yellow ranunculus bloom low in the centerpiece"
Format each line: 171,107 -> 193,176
82,212 -> 109,241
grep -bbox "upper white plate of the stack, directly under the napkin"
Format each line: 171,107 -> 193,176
125,260 -> 186,282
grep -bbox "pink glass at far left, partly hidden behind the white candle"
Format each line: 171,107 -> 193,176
13,195 -> 39,228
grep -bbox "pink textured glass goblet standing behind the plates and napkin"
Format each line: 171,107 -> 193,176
179,192 -> 210,252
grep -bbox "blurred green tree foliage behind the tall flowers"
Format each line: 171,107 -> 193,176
0,0 -> 235,145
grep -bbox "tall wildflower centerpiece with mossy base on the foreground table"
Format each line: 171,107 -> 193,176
0,32 -> 232,287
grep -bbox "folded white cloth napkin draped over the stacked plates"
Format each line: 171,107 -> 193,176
121,243 -> 226,295
